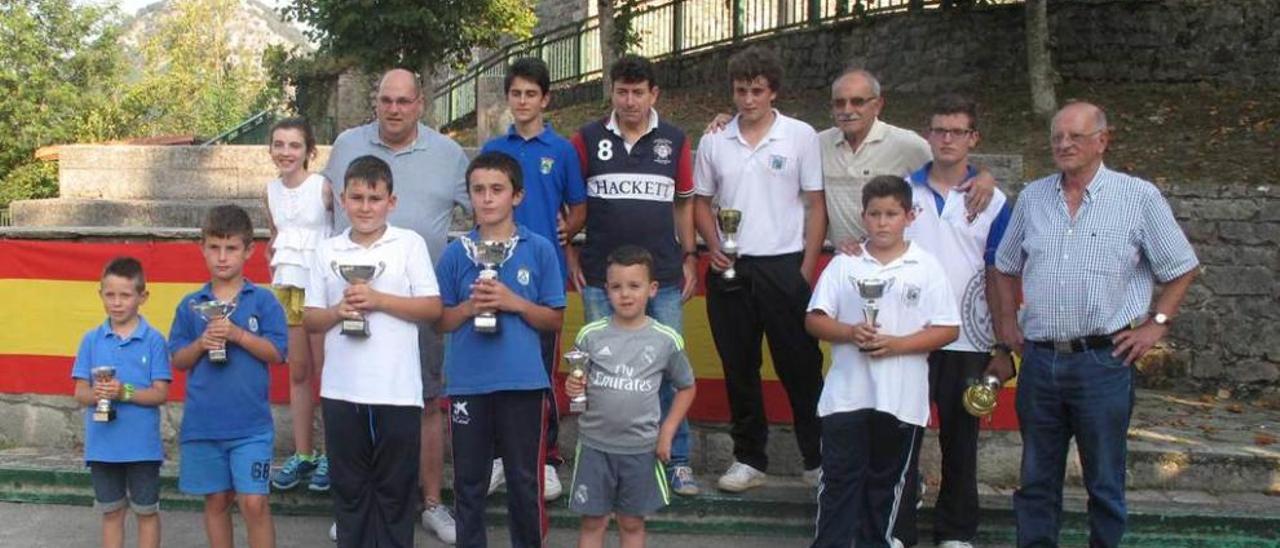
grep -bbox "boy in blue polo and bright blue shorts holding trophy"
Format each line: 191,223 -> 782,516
169,205 -> 288,548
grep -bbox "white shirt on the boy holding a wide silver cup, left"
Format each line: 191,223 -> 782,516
306,225 -> 440,407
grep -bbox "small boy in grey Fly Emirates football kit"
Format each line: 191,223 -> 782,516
564,246 -> 695,548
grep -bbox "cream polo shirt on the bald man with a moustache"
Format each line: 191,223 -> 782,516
818,119 -> 933,245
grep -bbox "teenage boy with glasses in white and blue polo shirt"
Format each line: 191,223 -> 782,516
896,93 -> 1011,548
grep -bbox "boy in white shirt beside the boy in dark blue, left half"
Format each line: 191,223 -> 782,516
303,156 -> 442,547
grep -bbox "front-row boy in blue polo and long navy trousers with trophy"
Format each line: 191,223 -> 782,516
435,152 -> 564,548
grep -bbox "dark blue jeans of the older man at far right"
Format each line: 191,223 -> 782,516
1014,343 -> 1134,547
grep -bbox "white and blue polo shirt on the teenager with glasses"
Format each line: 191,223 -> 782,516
904,175 -> 1009,352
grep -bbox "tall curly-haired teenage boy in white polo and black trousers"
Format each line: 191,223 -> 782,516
694,47 -> 827,492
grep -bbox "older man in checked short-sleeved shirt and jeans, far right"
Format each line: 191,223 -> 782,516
989,102 -> 1199,547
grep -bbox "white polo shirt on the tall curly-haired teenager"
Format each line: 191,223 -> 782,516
694,110 -> 823,256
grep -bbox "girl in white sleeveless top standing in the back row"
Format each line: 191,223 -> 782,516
266,118 -> 333,492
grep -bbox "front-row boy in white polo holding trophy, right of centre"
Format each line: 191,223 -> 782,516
805,175 -> 960,548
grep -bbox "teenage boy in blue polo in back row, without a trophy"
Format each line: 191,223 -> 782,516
481,58 -> 586,501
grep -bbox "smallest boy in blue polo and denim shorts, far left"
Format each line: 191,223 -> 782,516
72,257 -> 173,548
